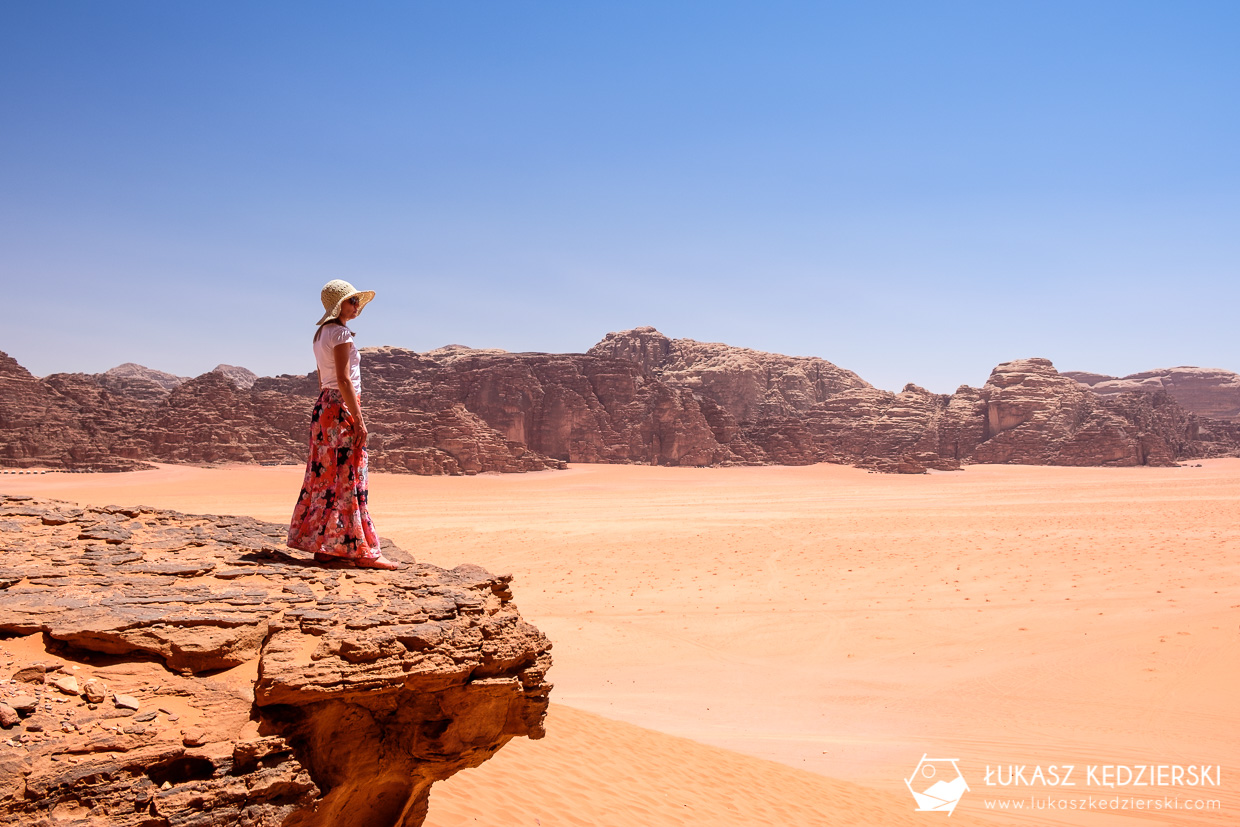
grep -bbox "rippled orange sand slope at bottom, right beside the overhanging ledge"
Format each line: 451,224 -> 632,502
427,704 -> 923,827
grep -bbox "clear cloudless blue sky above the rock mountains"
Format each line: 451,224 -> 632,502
0,0 -> 1240,392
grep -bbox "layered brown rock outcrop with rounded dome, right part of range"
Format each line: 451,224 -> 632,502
740,358 -> 1195,474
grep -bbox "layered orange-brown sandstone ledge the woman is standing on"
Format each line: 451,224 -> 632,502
0,496 -> 551,827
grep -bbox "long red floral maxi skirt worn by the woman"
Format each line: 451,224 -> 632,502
289,388 -> 381,560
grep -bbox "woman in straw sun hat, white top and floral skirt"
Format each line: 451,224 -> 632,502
289,279 -> 401,569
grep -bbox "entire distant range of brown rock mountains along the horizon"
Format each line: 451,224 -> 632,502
0,327 -> 1240,474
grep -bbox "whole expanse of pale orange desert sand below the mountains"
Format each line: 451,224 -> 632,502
0,460 -> 1240,827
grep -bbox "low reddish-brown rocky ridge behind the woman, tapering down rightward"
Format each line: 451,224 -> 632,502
0,353 -> 564,474
